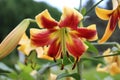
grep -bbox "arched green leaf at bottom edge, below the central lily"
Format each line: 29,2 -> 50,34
56,73 -> 80,80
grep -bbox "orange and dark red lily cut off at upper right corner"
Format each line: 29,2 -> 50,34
95,0 -> 120,43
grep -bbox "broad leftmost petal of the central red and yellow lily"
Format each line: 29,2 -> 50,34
30,29 -> 56,46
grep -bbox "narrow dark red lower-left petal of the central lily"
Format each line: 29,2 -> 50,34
47,39 -> 61,59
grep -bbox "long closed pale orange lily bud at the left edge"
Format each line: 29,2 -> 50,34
0,19 -> 30,59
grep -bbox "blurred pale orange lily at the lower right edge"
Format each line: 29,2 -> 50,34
97,49 -> 120,75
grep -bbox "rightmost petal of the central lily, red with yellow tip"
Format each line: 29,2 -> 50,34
77,24 -> 98,41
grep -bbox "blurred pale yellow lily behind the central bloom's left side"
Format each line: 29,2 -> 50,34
18,34 -> 53,60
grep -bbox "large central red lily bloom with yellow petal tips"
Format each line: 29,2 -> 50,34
31,7 -> 97,68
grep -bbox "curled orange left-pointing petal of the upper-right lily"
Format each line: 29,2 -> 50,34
95,7 -> 114,20
